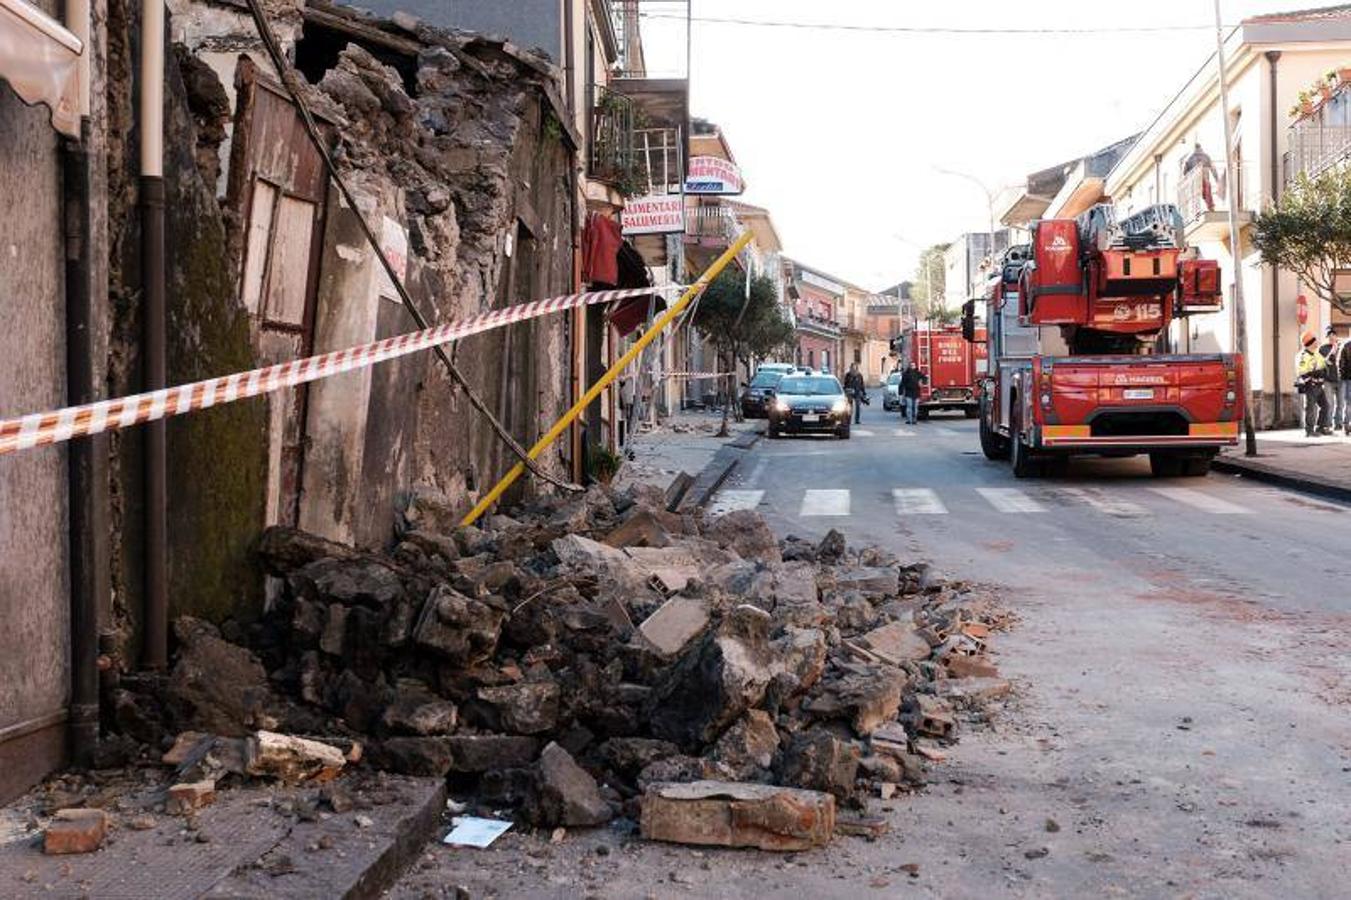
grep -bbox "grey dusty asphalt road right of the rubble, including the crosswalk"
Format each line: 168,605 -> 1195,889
715,391 -> 1351,897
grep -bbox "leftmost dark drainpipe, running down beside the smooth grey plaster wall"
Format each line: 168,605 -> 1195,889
61,0 -> 108,768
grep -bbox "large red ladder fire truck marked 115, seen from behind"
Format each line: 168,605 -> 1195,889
962,204 -> 1243,478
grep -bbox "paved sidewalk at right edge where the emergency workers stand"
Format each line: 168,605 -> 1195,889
1215,428 -> 1351,501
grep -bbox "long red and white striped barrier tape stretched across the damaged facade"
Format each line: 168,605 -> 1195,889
0,285 -> 684,455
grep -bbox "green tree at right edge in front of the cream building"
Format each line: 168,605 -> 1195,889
1252,166 -> 1351,312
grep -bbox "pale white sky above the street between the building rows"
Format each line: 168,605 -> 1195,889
640,0 -> 1286,289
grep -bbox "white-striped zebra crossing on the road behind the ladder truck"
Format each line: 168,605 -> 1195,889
708,485 -> 1347,519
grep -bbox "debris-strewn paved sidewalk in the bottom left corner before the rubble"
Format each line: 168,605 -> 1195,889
0,765 -> 446,900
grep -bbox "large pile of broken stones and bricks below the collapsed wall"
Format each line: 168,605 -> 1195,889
108,475 -> 1008,849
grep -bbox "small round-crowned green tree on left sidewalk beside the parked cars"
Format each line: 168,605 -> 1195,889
694,269 -> 793,434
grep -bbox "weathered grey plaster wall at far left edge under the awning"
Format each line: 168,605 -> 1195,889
0,84 -> 70,772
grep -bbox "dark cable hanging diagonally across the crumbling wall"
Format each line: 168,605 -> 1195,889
247,0 -> 584,492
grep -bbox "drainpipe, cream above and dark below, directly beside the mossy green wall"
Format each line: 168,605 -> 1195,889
139,0 -> 169,669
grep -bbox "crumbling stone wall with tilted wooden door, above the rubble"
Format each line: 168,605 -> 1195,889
98,0 -> 576,637
